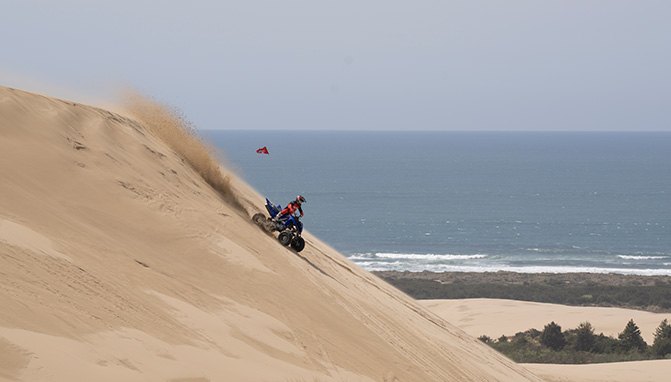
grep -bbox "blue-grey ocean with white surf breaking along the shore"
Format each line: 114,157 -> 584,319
200,131 -> 671,275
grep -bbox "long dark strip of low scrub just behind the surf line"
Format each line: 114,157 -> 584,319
375,272 -> 671,312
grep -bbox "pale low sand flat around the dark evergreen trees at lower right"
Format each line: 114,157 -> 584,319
420,298 -> 671,382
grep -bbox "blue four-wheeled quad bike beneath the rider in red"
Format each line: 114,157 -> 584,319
252,198 -> 305,252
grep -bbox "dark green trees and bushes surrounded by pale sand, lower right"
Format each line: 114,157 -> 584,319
479,320 -> 671,364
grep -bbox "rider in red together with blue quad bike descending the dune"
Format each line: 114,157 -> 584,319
252,195 -> 305,252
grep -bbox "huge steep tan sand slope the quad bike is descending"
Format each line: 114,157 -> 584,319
0,88 -> 539,381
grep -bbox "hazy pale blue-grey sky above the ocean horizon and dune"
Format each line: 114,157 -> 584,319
0,0 -> 671,131
